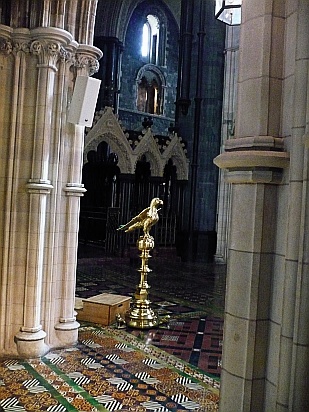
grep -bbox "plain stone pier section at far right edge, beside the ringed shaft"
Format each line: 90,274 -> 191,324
276,0 -> 309,412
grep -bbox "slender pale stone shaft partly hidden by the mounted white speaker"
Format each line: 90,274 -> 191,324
55,45 -> 102,344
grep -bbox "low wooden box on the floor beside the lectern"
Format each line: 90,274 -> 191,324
77,293 -> 131,326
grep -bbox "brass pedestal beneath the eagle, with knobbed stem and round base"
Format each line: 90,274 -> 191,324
125,235 -> 159,329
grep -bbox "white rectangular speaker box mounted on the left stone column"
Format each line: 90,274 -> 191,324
68,76 -> 101,127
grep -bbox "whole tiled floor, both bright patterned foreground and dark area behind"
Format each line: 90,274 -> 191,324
0,246 -> 225,412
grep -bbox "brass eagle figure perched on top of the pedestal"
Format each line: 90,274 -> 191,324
117,197 -> 163,237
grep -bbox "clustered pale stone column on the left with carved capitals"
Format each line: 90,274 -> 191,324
0,26 -> 102,357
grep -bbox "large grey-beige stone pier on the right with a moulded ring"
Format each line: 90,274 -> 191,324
215,0 -> 309,412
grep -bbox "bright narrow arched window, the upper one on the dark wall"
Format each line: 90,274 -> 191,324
141,14 -> 160,64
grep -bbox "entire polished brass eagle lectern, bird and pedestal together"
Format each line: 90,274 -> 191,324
118,197 -> 163,329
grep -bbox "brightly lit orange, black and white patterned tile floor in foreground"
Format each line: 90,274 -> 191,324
0,325 -> 219,412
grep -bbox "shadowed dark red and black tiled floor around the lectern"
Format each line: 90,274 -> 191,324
76,249 -> 225,376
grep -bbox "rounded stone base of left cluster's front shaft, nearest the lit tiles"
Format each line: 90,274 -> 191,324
14,330 -> 49,358
